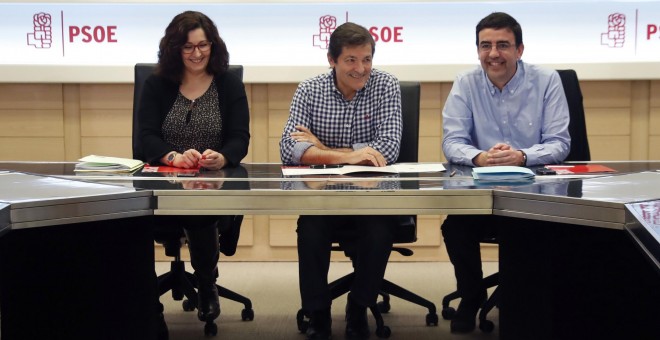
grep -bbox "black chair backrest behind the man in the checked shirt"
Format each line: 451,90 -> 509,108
397,81 -> 420,163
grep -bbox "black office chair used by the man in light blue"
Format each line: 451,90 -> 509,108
441,69 -> 591,333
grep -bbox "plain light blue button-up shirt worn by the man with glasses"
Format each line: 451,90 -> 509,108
442,61 -> 571,166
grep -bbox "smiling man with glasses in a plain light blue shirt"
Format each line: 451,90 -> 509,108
442,13 -> 571,333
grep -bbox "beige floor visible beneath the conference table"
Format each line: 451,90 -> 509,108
156,260 -> 498,340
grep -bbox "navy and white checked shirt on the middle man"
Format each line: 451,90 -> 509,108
280,69 -> 403,165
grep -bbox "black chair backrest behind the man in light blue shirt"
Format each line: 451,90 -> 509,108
557,70 -> 591,161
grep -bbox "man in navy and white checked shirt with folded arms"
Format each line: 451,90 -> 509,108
280,23 -> 402,339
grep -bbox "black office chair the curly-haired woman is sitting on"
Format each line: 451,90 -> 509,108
133,63 -> 254,335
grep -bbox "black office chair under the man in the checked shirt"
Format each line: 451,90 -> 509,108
296,82 -> 438,338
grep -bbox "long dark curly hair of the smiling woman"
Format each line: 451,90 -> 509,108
156,11 -> 229,83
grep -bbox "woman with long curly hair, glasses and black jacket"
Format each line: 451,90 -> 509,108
138,11 -> 250,334
